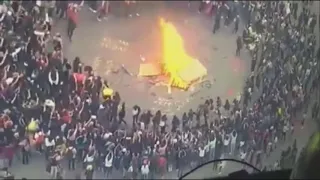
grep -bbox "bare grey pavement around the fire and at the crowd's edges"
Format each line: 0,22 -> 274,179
6,1 -> 319,179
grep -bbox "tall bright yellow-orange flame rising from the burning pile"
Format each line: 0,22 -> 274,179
160,18 -> 207,90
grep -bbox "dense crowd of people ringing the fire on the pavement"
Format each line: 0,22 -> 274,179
0,1 -> 320,179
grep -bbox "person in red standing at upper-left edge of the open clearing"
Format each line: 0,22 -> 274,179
67,4 -> 78,41
